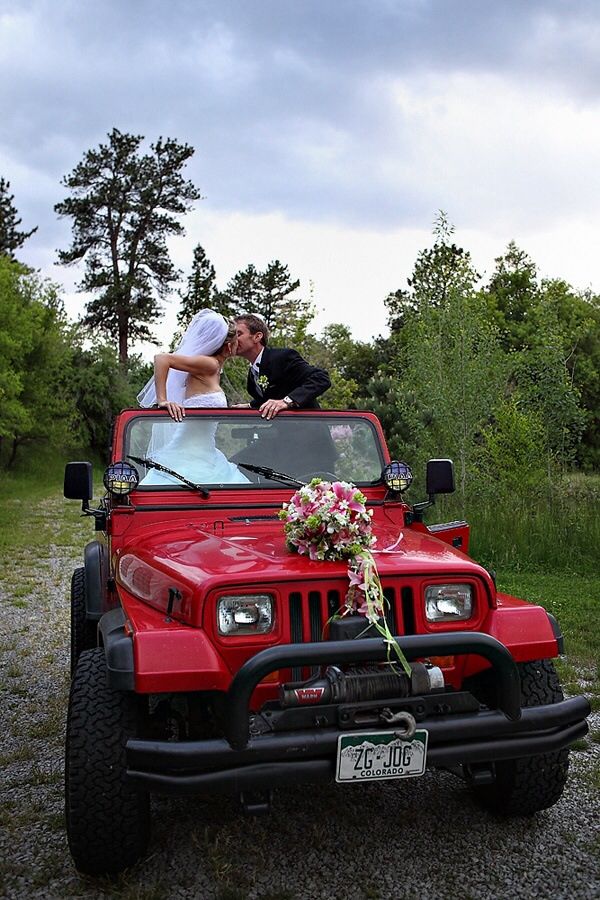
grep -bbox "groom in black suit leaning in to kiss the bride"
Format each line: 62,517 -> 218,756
235,313 -> 331,419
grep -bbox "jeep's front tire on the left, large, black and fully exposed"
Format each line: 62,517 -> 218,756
65,647 -> 150,875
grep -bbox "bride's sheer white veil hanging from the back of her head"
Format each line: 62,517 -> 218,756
137,309 -> 229,408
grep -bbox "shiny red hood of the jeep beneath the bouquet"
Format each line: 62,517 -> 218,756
116,522 -> 489,624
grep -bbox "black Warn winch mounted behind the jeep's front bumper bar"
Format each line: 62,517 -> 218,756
279,663 -> 444,707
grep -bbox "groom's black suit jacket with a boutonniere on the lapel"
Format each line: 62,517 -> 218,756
247,347 -> 331,409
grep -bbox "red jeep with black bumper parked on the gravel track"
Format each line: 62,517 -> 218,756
65,409 -> 589,874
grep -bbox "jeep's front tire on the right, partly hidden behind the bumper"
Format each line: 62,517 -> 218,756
473,660 -> 569,816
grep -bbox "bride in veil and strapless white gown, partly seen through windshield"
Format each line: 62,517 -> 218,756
137,309 -> 249,485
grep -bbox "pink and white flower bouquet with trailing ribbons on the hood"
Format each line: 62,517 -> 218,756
279,478 -> 411,675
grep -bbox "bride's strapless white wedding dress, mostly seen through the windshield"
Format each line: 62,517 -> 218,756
140,391 -> 250,486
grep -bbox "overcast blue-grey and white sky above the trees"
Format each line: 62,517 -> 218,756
0,0 -> 600,341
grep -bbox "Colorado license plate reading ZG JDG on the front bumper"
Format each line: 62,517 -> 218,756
335,729 -> 428,782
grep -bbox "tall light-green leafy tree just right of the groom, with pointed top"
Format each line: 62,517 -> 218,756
378,213 -> 506,501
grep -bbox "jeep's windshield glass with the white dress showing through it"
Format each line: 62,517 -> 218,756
123,412 -> 384,490
